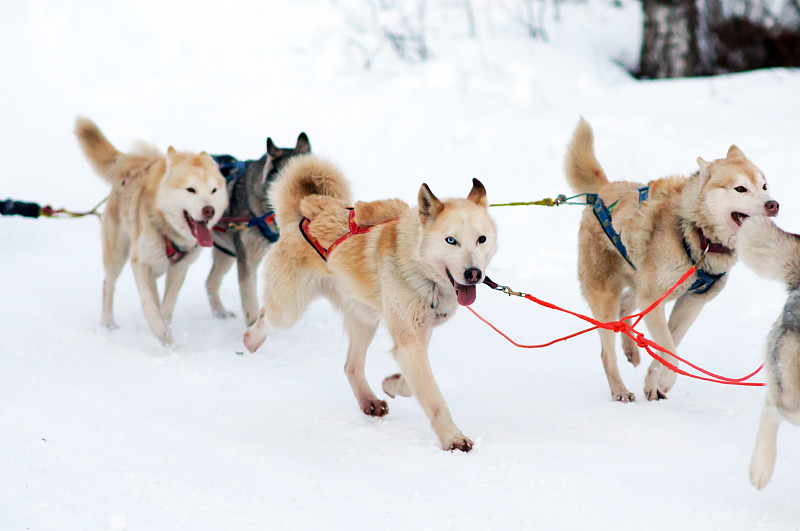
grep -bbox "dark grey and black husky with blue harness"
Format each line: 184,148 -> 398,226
206,133 -> 311,326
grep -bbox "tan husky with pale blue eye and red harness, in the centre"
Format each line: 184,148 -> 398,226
244,155 -> 497,452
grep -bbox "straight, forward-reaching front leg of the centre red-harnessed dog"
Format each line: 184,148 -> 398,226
389,324 -> 473,452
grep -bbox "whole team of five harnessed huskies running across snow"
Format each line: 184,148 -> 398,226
75,118 -> 800,489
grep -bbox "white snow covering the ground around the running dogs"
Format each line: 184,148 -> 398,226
0,0 -> 800,530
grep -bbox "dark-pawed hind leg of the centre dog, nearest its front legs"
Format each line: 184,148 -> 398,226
344,310 -> 389,417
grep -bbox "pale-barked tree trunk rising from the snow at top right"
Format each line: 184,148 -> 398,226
639,0 -> 699,79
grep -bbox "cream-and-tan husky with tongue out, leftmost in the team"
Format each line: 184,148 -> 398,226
75,118 -> 228,345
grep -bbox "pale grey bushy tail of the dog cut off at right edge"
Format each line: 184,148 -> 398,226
736,216 -> 800,288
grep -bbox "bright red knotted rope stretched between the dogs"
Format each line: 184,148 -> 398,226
467,266 -> 764,387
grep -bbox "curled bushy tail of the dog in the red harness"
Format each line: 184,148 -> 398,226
268,153 -> 352,232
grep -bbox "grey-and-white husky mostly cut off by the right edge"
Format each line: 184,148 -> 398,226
736,217 -> 800,489
